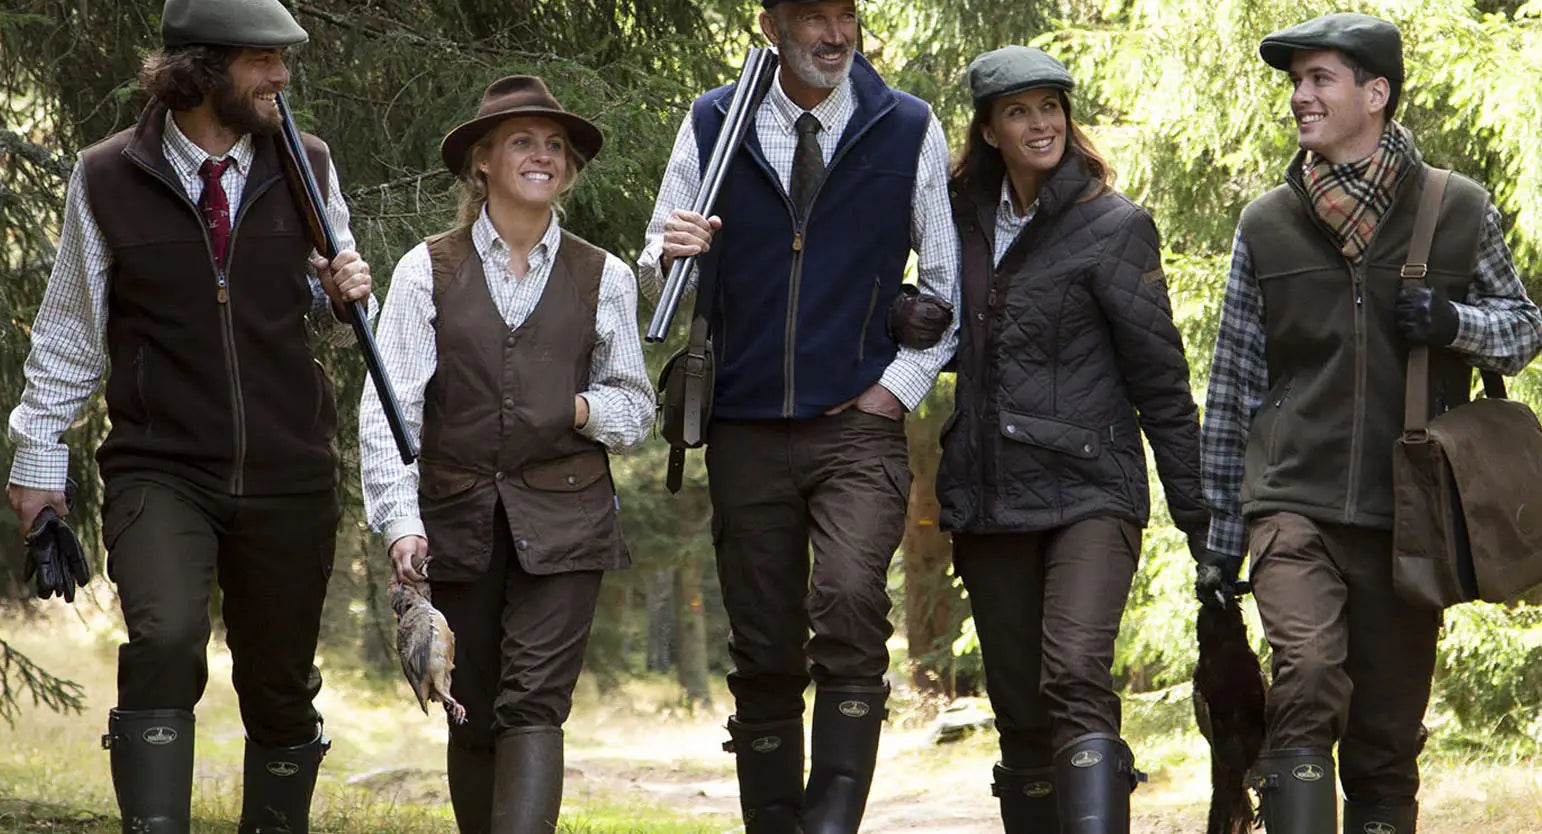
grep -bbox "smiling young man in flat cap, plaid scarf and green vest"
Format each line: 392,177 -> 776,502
1197,14 -> 1542,834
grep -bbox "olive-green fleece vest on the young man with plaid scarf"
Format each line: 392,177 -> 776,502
1240,154 -> 1488,529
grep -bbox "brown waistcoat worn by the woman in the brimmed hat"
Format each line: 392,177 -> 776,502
418,227 -> 631,581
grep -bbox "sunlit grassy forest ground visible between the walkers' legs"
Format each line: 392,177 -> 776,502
0,606 -> 1542,834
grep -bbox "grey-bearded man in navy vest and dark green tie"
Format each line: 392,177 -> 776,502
638,0 -> 958,834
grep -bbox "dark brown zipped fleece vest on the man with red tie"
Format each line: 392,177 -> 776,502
80,103 -> 338,495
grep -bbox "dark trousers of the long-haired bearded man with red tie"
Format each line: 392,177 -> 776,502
102,472 -> 338,748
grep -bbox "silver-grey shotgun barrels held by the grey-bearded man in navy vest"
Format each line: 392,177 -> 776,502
645,46 -> 777,344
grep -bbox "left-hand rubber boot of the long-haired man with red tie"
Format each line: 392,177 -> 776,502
102,709 -> 194,834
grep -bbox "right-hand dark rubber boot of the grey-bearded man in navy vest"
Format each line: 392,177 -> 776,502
803,686 -> 888,834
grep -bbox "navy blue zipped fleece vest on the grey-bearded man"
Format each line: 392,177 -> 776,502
691,55 -> 930,419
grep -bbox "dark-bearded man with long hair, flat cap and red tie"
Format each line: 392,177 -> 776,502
6,0 -> 370,834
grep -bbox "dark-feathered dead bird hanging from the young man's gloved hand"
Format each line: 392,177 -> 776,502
1194,597 -> 1264,834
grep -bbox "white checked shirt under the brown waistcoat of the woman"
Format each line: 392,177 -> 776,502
359,208 -> 654,541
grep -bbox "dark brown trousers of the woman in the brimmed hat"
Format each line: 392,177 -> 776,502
429,501 -> 603,752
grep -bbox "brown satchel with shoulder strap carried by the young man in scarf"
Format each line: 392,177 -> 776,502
1392,168 -> 1542,609
